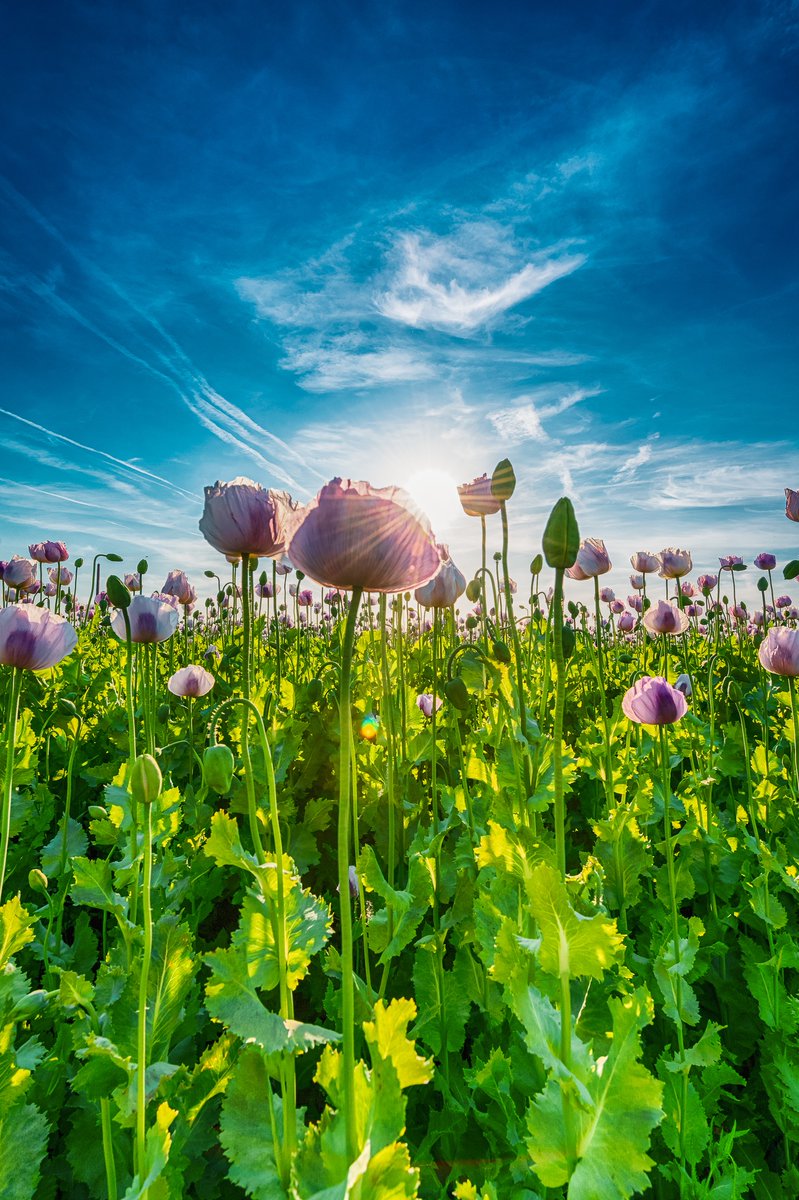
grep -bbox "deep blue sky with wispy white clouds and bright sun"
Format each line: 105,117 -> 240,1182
0,0 -> 799,600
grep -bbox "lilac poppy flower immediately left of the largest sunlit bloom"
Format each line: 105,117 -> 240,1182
199,476 -> 298,558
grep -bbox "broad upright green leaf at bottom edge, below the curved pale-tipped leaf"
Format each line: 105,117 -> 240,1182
220,1046 -> 292,1200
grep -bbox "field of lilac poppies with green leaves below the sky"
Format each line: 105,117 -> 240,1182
0,461 -> 799,1200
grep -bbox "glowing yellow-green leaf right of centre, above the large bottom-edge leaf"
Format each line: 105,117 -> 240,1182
528,863 -> 624,979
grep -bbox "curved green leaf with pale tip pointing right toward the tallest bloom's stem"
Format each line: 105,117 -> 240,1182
204,947 -> 340,1054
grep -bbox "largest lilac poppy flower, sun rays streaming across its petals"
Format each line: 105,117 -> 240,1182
289,478 -> 441,593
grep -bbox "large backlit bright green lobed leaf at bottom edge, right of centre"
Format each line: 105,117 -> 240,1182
528,988 -> 663,1200
